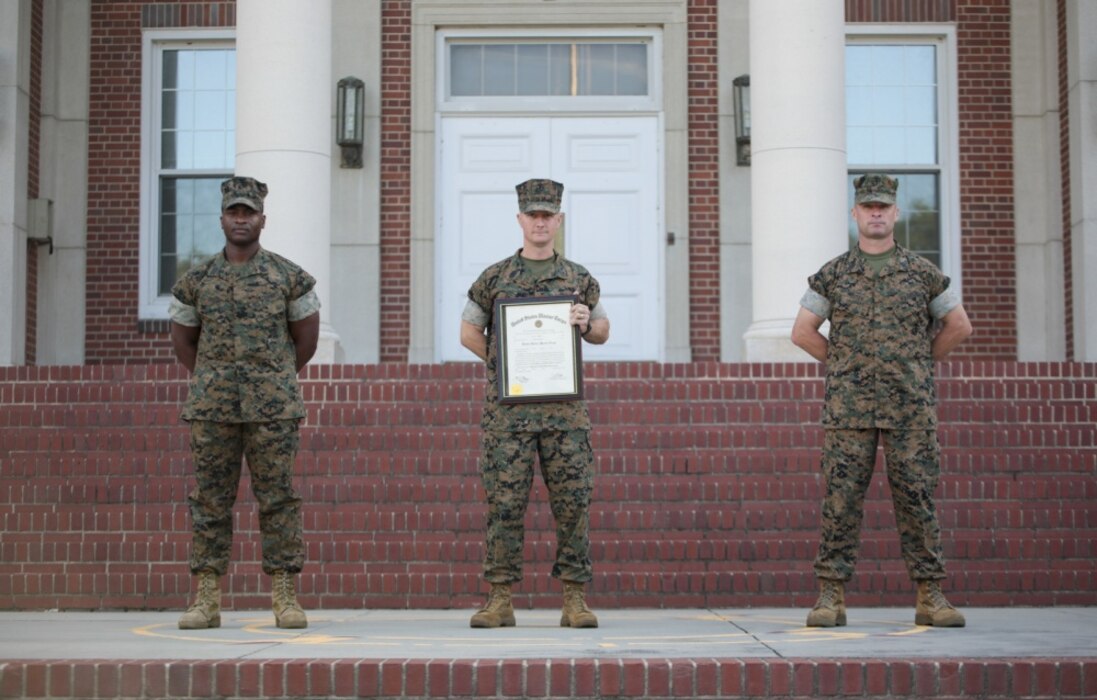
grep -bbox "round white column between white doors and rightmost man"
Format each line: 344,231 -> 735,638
744,0 -> 849,362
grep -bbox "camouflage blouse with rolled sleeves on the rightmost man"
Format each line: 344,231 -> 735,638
801,246 -> 960,429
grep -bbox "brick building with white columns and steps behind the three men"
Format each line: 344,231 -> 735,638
0,0 -> 1097,607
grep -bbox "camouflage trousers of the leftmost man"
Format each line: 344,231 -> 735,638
188,419 -> 305,575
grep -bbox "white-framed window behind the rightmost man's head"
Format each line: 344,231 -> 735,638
846,33 -> 959,278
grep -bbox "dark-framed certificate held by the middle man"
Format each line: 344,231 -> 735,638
494,296 -> 583,404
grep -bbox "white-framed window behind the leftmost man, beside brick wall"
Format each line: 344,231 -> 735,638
140,35 -> 236,318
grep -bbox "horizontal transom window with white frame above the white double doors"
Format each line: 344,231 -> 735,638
440,31 -> 658,111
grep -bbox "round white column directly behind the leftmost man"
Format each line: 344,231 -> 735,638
236,0 -> 339,363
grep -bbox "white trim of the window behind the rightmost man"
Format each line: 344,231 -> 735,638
846,24 -> 963,293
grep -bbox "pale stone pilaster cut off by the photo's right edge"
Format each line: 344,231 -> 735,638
1066,0 -> 1097,362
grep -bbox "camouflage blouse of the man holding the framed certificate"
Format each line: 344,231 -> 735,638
468,246 -> 601,432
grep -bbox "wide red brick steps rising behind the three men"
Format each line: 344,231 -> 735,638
0,362 -> 1097,609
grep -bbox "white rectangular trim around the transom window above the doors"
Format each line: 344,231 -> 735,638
434,26 -> 663,114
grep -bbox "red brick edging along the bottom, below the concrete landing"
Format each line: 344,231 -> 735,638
0,656 -> 1097,700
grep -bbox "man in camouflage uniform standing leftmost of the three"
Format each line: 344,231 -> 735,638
170,178 -> 319,629
